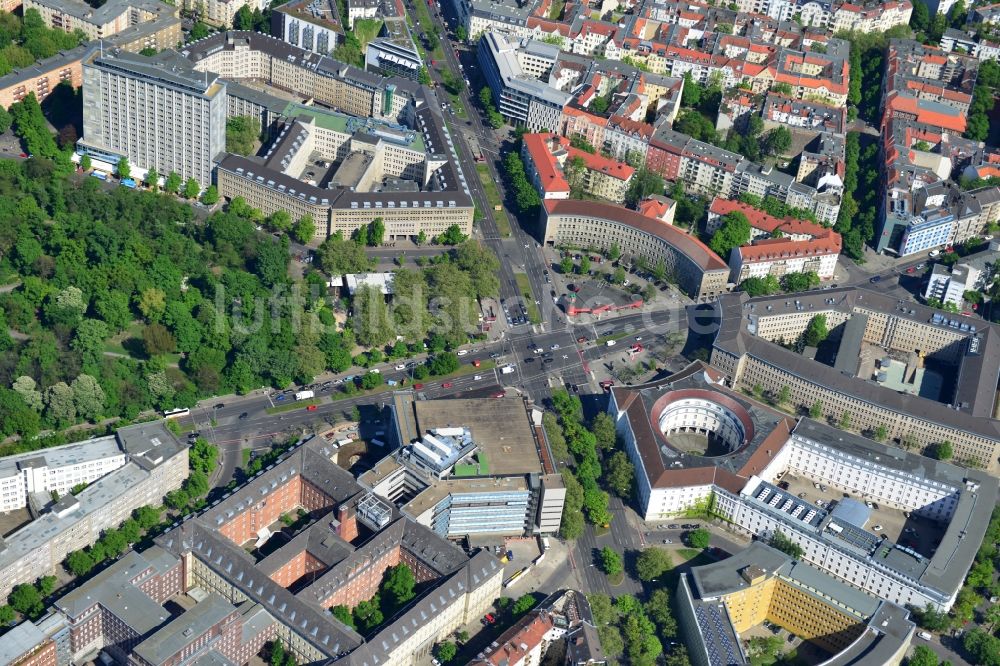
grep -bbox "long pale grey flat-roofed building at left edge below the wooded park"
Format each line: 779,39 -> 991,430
0,422 -> 188,596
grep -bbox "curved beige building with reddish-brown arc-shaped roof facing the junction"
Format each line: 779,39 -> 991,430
542,199 -> 729,300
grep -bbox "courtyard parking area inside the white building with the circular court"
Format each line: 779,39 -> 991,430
781,474 -> 945,557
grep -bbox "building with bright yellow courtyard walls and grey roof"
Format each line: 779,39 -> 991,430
678,542 -> 916,666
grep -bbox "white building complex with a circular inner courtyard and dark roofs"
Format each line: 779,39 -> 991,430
609,363 -> 997,610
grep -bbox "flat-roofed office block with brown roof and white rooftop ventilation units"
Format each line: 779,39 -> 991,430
358,392 -> 566,539
